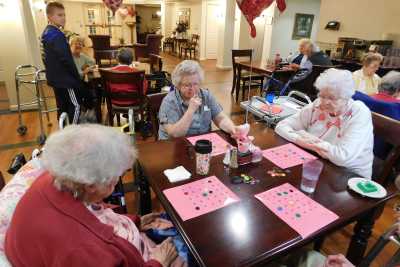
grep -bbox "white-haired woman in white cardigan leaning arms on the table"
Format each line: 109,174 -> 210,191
275,68 -> 373,178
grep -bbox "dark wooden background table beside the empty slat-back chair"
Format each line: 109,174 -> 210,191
234,61 -> 295,99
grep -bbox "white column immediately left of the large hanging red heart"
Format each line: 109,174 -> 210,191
217,0 -> 236,69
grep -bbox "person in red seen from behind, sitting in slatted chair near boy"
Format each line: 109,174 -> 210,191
110,48 -> 148,106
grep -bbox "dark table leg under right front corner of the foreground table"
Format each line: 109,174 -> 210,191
346,205 -> 384,266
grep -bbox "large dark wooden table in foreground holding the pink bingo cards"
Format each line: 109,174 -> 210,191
138,123 -> 396,267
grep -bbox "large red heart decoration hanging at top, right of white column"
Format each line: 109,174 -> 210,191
236,0 -> 286,38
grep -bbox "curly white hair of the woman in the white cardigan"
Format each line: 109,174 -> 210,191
314,68 -> 355,99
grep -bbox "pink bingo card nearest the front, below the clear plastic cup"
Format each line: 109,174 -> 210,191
255,183 -> 339,238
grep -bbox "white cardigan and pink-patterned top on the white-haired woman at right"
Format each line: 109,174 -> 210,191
275,99 -> 374,179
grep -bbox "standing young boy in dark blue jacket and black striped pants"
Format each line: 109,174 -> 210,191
42,2 -> 82,123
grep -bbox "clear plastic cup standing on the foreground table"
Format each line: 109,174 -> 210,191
300,160 -> 324,194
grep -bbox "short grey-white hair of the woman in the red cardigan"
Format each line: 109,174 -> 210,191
42,124 -> 137,186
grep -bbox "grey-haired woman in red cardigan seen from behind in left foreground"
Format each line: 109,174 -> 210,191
5,124 -> 177,267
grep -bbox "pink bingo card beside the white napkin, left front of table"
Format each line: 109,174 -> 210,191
163,176 -> 239,221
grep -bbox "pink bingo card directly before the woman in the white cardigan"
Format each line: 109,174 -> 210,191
263,143 -> 317,169
